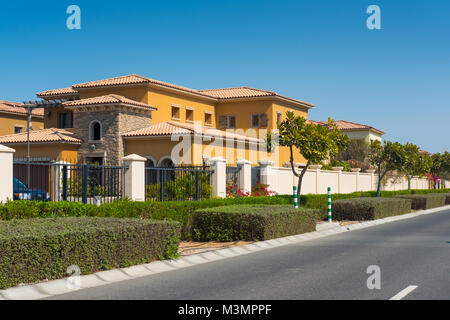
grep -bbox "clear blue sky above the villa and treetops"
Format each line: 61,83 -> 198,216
0,0 -> 450,152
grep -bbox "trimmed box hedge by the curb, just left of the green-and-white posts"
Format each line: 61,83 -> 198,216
193,205 -> 318,241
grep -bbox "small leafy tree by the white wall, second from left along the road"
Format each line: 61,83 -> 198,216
368,140 -> 406,197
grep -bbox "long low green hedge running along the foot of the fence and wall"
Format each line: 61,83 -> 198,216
0,189 -> 450,239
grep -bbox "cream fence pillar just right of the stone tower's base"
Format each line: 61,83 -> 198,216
122,154 -> 147,201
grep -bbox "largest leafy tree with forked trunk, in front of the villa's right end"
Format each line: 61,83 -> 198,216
278,111 -> 350,199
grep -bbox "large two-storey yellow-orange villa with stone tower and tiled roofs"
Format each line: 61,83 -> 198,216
0,74 -> 313,166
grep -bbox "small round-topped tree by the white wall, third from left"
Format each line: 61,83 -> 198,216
402,142 -> 432,190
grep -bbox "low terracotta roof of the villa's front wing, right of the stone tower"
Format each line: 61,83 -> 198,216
123,121 -> 260,142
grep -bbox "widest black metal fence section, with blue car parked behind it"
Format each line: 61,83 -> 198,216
13,160 -> 126,204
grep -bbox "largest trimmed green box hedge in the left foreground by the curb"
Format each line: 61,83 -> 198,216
0,217 -> 180,289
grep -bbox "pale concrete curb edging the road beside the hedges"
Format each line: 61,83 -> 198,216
0,205 -> 450,300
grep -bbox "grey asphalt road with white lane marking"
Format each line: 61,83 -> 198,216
47,210 -> 450,300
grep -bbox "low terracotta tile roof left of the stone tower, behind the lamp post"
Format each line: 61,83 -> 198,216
0,128 -> 82,144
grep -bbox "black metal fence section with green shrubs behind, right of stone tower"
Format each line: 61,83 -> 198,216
145,166 -> 212,201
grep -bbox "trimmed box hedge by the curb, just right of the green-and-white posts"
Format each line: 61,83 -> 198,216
333,198 -> 411,221
